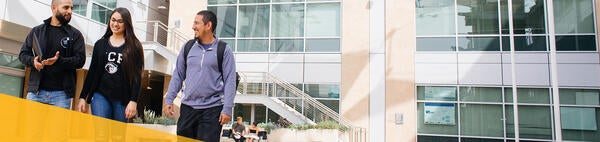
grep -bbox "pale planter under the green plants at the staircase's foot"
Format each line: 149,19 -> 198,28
268,128 -> 348,142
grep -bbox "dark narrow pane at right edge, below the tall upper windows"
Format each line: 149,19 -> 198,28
556,35 -> 596,51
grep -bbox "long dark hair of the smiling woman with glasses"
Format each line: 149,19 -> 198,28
102,7 -> 144,86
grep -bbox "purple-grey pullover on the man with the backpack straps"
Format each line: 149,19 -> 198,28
166,38 -> 236,116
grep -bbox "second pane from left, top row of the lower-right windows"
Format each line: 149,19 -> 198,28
460,87 -> 502,103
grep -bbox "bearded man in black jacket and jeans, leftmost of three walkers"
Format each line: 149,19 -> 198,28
19,0 -> 85,109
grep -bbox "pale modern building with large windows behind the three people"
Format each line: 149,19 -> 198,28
0,0 -> 600,142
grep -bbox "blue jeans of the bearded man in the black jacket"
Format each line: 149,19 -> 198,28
27,89 -> 71,109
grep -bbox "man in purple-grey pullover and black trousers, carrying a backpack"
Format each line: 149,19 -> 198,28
164,10 -> 236,142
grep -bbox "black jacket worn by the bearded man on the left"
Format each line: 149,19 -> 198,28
19,18 -> 85,98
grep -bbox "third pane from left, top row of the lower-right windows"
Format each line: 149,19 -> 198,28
504,88 -> 550,104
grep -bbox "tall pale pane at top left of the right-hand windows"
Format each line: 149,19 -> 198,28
416,0 -> 455,35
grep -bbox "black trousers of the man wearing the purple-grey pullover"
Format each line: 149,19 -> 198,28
177,104 -> 223,142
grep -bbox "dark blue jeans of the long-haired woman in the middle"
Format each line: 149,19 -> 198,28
91,92 -> 127,122
